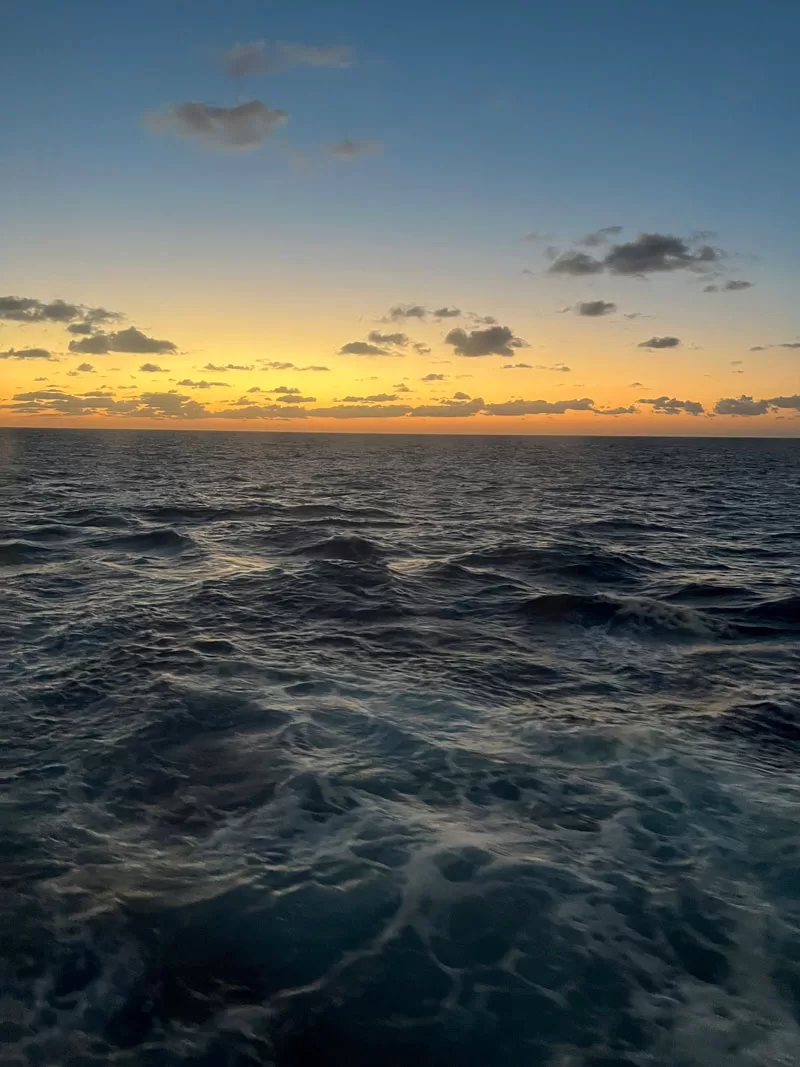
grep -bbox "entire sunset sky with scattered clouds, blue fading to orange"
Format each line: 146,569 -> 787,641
0,0 -> 800,436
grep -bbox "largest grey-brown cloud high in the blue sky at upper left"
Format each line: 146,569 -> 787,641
145,100 -> 289,152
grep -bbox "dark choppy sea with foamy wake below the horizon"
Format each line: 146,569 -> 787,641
0,431 -> 800,1067
